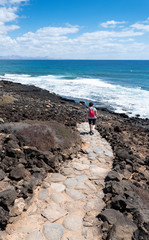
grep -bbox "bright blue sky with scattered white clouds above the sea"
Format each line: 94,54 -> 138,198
0,0 -> 149,60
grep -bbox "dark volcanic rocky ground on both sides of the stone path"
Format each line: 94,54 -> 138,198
0,81 -> 149,240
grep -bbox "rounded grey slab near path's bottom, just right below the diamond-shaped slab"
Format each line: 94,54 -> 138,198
63,215 -> 82,232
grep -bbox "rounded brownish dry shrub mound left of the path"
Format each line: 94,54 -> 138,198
0,120 -> 79,151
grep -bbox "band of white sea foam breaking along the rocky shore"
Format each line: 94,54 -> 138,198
1,74 -> 149,118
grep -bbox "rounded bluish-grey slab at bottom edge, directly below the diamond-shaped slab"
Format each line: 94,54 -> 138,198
43,223 -> 65,240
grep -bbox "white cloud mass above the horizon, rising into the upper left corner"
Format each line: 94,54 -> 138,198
0,8 -> 149,59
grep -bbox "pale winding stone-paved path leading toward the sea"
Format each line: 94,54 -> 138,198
4,123 -> 113,240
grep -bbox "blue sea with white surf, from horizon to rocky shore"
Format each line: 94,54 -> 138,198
0,60 -> 149,118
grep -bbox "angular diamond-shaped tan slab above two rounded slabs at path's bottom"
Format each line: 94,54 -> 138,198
42,203 -> 67,222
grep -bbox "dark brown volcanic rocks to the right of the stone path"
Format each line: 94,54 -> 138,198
97,109 -> 149,240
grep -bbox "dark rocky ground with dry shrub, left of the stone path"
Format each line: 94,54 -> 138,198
0,81 -> 84,233
